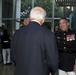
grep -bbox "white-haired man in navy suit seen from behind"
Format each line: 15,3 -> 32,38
11,7 -> 58,75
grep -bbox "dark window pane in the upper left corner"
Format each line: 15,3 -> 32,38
2,0 -> 13,18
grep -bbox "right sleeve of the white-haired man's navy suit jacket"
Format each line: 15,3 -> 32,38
45,31 -> 58,74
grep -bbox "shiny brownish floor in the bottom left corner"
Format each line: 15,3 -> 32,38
0,63 -> 14,75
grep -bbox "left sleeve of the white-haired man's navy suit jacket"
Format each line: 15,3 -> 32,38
10,31 -> 17,65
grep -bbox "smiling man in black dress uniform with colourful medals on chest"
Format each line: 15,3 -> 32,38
56,17 -> 76,75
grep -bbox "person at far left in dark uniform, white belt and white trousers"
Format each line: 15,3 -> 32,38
1,29 -> 11,64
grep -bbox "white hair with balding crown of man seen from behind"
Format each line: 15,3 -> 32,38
30,7 -> 46,20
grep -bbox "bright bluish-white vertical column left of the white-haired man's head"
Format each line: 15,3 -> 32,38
16,0 -> 21,30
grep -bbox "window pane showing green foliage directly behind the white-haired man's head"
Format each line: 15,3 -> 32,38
35,0 -> 52,17
